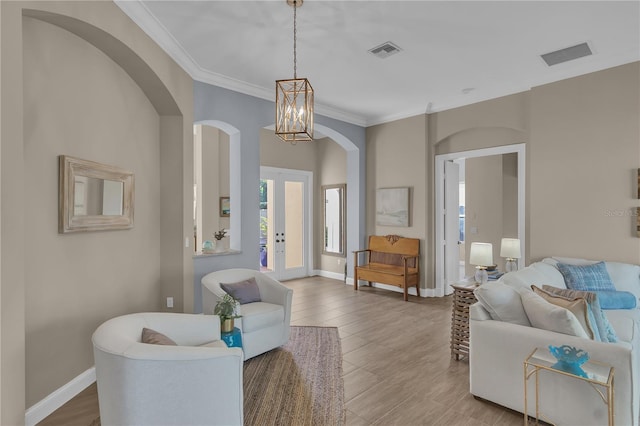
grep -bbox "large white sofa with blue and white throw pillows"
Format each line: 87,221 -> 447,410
469,258 -> 640,426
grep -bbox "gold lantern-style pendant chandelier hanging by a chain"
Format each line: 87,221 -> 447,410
276,0 -> 313,144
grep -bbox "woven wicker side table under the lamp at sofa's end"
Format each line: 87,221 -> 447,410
451,281 -> 478,361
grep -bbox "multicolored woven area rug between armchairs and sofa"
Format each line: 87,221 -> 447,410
244,326 -> 345,426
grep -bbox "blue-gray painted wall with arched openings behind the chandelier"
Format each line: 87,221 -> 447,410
193,81 -> 365,312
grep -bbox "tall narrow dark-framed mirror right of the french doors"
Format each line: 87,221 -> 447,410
322,184 -> 347,257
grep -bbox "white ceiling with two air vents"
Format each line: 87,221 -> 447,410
116,0 -> 640,126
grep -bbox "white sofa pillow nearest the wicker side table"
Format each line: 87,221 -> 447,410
473,282 -> 531,327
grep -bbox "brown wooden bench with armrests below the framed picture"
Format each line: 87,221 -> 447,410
353,235 -> 420,301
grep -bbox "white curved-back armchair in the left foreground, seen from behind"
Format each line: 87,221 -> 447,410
92,313 -> 243,426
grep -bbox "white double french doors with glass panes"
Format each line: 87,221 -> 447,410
260,167 -> 312,280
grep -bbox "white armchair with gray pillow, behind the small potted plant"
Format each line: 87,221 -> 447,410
201,268 -> 293,359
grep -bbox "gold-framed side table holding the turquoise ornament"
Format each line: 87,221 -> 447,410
524,348 -> 614,426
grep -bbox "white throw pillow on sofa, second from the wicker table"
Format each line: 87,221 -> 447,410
520,291 -> 589,339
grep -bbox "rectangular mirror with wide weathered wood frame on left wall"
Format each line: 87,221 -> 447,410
58,155 -> 134,234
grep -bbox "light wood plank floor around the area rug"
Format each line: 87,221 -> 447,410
40,277 -> 522,426
